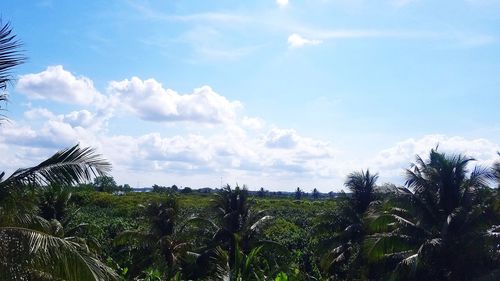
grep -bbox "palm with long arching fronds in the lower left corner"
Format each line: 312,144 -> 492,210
0,145 -> 116,280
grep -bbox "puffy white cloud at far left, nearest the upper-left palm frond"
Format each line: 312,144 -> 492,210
16,65 -> 103,105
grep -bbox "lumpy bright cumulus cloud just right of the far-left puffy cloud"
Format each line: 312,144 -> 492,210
108,77 -> 242,124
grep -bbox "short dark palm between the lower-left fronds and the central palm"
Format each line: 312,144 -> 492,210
115,195 -> 189,280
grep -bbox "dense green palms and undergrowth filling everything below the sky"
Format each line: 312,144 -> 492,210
0,18 -> 500,281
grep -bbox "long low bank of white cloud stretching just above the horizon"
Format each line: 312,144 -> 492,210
0,110 -> 500,191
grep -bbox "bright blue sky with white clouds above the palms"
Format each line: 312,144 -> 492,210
0,0 -> 500,192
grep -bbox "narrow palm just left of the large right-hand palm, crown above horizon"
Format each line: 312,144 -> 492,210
316,170 -> 378,280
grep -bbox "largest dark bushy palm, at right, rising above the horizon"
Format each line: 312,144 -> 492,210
366,149 -> 500,281
